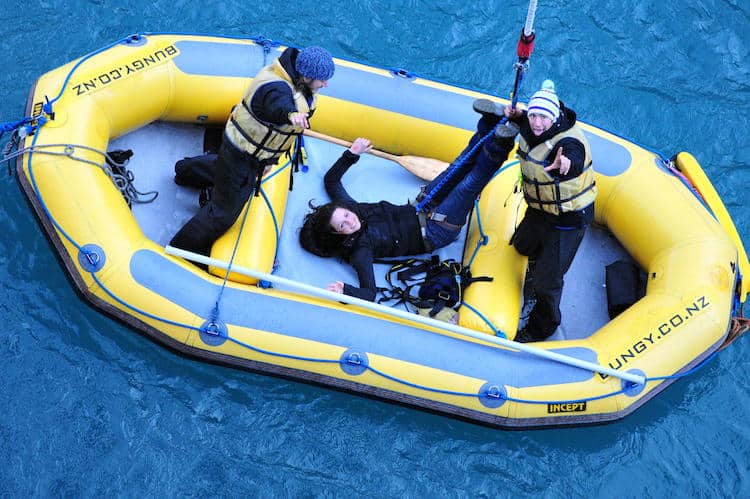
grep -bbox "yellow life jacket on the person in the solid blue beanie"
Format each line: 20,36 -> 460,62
224,59 -> 317,166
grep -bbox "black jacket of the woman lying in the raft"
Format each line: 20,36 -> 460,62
324,150 -> 426,301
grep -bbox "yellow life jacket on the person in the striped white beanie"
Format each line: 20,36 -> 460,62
518,125 -> 596,215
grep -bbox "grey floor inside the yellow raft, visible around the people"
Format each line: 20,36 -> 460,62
109,123 -> 629,340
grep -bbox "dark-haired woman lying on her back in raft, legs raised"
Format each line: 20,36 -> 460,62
299,106 -> 519,301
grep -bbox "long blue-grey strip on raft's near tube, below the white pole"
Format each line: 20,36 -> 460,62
130,250 -> 597,387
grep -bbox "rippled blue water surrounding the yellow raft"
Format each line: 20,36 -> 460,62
0,0 -> 750,497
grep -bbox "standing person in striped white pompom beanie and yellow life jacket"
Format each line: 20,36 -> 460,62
475,80 -> 596,343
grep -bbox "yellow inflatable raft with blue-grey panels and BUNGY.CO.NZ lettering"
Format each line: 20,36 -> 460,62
17,34 -> 749,428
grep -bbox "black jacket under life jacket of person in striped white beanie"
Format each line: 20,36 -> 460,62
513,102 -> 594,227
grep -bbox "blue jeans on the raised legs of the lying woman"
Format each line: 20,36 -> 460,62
425,117 -> 513,248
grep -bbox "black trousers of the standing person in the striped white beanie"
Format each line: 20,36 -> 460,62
511,209 -> 586,340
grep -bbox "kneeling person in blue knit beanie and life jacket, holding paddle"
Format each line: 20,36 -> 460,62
169,47 -> 335,255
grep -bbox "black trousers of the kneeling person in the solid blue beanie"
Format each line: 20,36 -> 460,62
169,140 -> 261,255
